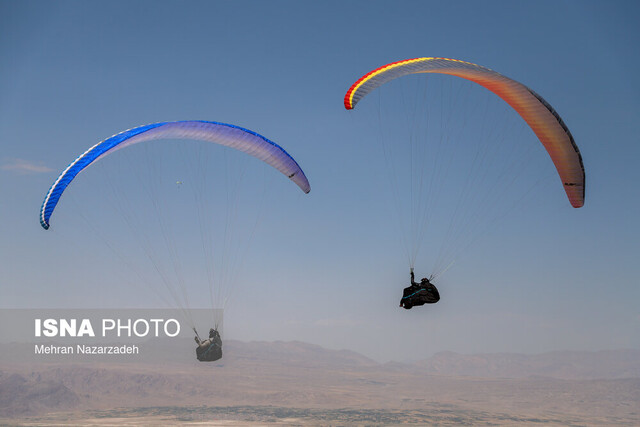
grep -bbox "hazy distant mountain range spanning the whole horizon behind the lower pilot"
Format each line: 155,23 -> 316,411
0,340 -> 640,380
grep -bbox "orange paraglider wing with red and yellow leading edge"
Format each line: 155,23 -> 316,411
344,58 -> 585,208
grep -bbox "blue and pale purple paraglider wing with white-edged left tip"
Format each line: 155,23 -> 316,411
40,120 -> 311,230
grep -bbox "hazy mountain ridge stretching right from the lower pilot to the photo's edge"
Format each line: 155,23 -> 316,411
225,340 -> 640,380
